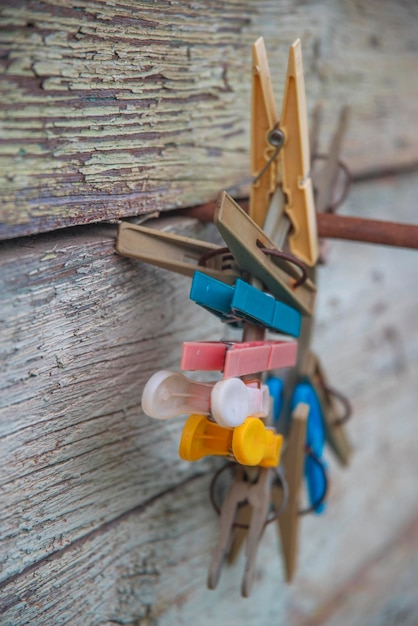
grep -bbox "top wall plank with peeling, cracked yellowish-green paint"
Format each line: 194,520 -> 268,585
0,0 -> 418,238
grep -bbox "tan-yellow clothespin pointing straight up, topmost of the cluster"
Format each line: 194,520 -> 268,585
249,37 -> 318,267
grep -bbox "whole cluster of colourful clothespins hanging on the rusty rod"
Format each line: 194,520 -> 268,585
117,38 -> 418,596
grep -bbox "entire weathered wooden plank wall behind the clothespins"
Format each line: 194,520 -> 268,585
0,0 -> 418,626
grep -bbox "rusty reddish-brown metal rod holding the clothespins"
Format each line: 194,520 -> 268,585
182,198 -> 418,249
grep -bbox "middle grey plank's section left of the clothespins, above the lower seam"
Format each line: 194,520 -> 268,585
0,220 -> 222,580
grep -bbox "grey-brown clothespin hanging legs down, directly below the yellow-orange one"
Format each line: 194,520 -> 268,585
208,467 -> 272,597
